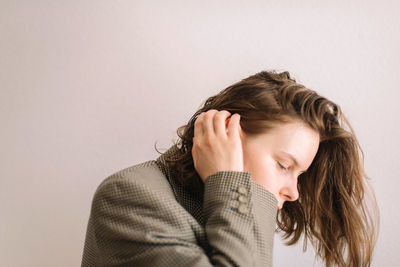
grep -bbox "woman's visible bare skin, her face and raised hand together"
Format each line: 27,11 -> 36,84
192,109 -> 320,209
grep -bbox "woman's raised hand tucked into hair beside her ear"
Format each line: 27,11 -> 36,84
192,109 -> 243,182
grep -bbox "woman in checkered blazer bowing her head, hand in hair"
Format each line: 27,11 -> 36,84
82,71 -> 379,266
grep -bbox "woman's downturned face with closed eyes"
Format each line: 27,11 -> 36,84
240,122 -> 320,209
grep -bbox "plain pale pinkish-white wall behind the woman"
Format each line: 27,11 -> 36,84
0,0 -> 400,267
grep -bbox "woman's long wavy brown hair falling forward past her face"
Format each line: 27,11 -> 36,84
156,71 -> 379,266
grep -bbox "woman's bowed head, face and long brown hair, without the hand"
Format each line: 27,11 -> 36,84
155,71 -> 378,266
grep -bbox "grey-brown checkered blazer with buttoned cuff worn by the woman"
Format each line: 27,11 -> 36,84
82,145 -> 277,267
